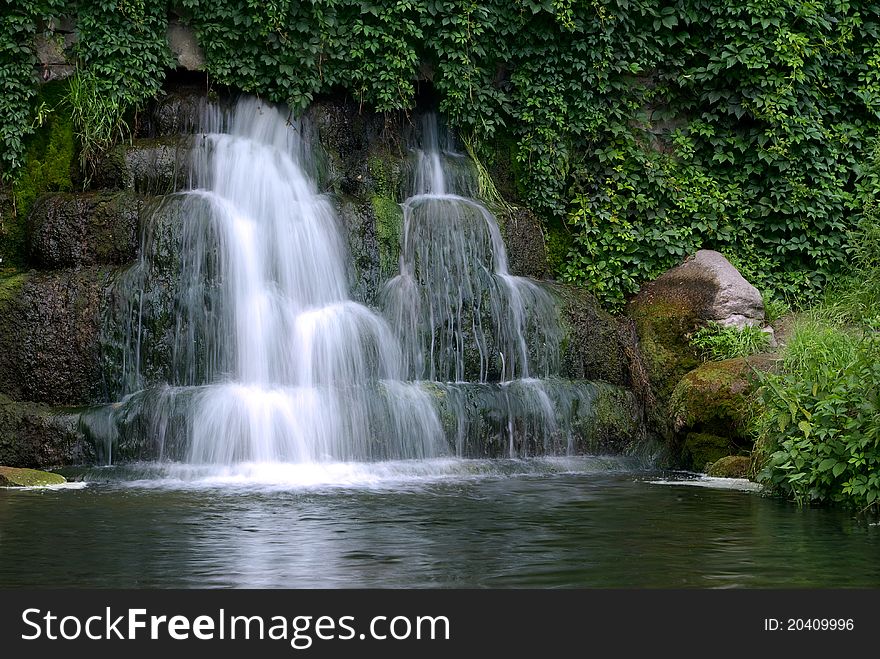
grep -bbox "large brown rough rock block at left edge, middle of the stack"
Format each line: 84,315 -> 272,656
0,268 -> 109,405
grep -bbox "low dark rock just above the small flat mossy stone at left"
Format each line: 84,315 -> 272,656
0,394 -> 95,468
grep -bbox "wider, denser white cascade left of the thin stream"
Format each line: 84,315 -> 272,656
93,99 -> 445,465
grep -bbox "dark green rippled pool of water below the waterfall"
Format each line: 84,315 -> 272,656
0,458 -> 880,588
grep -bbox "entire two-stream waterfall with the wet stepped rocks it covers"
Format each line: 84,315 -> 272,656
81,99 -> 632,475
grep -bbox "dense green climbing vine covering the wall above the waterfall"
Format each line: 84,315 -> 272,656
0,0 -> 880,305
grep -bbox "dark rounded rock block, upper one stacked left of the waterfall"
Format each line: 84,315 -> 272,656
29,192 -> 144,269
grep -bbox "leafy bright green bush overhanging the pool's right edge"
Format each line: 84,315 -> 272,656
758,326 -> 880,510
